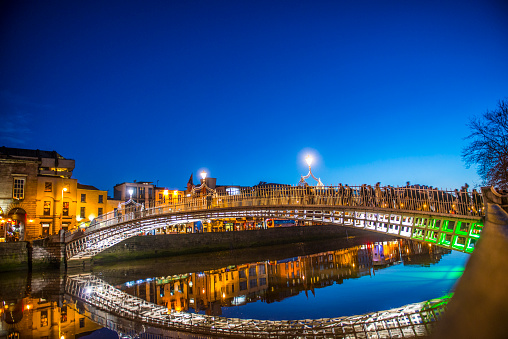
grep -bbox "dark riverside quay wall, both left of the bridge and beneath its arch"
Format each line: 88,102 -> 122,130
0,225 -> 380,272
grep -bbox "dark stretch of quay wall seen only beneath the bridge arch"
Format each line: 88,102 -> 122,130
92,225 -> 375,264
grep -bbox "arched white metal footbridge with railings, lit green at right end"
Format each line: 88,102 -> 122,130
65,185 -> 484,260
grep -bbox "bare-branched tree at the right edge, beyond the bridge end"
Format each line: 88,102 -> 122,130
462,99 -> 508,189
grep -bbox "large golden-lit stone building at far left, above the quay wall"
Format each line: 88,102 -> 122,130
0,146 -> 75,240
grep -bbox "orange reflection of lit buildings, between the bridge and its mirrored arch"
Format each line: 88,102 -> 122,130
118,240 -> 450,315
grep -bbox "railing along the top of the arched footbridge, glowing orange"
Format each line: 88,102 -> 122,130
85,185 -> 484,233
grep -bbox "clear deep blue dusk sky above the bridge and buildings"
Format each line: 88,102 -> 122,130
0,0 -> 508,192
